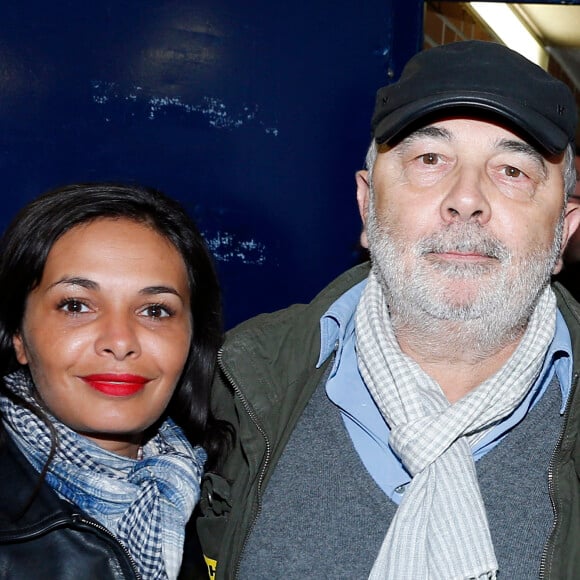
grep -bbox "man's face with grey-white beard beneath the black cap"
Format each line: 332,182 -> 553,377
358,119 -> 564,340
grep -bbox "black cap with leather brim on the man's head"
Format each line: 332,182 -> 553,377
371,40 -> 577,154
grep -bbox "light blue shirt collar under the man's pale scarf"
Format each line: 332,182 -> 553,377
317,280 -> 572,503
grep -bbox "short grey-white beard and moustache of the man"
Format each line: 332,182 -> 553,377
367,194 -> 564,356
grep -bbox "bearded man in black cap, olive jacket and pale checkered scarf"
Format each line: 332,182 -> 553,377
198,41 -> 580,580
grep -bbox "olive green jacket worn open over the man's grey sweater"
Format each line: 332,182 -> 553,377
197,264 -> 580,579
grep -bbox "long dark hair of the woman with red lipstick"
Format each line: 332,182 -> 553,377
0,183 -> 231,469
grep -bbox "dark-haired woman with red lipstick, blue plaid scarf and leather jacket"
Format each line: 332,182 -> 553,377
0,184 -> 229,579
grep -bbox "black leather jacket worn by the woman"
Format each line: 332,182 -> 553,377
0,433 -> 207,580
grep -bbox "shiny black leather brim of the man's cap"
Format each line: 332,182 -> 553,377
374,92 -> 568,155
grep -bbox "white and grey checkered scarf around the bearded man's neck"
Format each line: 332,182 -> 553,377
356,271 -> 556,580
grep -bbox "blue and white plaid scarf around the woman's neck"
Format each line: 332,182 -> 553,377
0,371 -> 206,580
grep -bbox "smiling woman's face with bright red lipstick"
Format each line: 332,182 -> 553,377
14,219 -> 192,456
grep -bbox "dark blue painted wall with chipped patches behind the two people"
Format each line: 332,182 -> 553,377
0,0 -> 422,326
